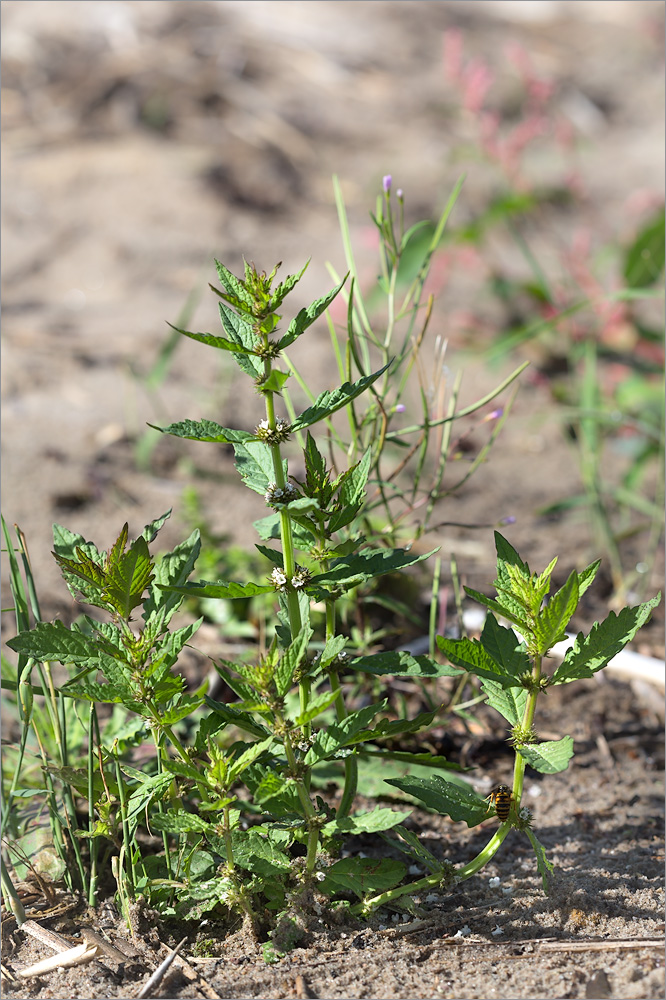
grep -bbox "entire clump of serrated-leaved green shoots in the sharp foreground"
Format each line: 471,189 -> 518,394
2,195 -> 656,960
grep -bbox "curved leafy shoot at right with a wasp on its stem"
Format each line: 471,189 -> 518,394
344,532 -> 661,915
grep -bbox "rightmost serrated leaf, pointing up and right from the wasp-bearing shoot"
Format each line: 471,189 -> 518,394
551,593 -> 661,684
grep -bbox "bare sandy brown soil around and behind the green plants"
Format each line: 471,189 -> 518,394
2,0 -> 664,1000
